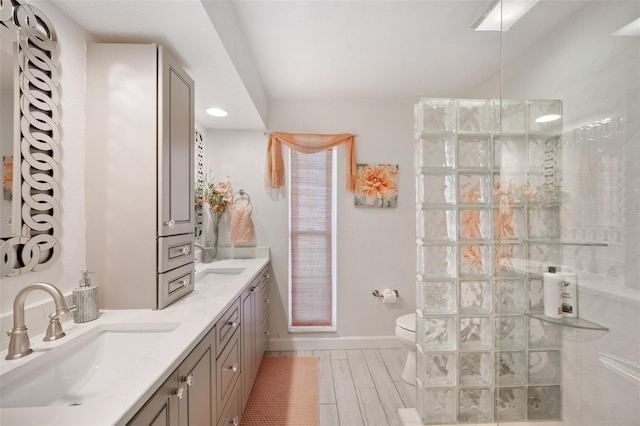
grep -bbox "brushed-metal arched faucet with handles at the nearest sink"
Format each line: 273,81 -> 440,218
5,283 -> 76,360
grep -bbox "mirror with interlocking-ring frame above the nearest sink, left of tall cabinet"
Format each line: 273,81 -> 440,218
0,0 -> 60,277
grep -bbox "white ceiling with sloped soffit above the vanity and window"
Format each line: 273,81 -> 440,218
54,0 -> 581,129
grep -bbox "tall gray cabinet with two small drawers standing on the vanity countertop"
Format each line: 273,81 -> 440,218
86,44 -> 195,309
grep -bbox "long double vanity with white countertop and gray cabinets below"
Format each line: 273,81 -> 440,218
0,257 -> 270,426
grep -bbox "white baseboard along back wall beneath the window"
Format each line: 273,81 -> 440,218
267,336 -> 404,352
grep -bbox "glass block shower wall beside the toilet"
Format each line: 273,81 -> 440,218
415,99 -> 562,424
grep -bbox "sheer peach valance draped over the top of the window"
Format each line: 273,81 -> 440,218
265,132 -> 357,192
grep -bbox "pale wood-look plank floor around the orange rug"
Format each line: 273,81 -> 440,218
265,348 -> 416,426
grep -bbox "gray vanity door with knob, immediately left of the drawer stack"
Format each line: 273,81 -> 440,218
178,330 -> 215,426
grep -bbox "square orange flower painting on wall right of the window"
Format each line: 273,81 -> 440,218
355,164 -> 398,208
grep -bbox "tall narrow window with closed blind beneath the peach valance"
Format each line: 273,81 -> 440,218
289,148 -> 336,331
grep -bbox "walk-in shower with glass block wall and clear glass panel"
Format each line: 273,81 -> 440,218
415,1 -> 640,426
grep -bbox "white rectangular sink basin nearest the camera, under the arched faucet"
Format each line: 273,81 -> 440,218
0,323 -> 179,408
